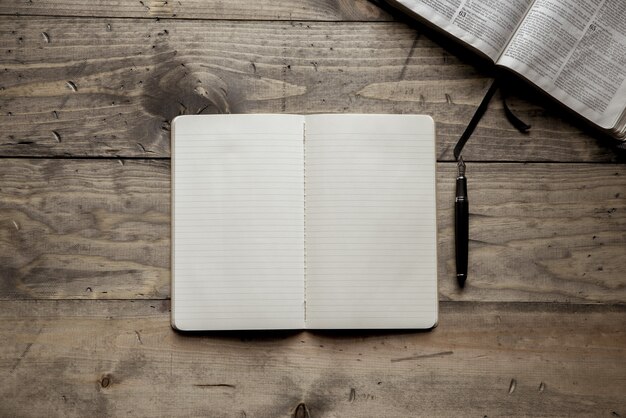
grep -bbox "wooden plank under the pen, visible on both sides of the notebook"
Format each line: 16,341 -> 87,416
0,159 -> 626,303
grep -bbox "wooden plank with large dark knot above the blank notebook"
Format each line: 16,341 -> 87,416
0,16 -> 617,162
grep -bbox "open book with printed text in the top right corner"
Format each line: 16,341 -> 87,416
389,0 -> 626,140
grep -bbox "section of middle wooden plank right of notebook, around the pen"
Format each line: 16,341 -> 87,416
437,164 -> 626,302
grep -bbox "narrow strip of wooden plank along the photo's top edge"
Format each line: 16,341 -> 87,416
0,0 -> 391,21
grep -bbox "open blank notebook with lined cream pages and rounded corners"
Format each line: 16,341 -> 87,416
172,115 -> 437,330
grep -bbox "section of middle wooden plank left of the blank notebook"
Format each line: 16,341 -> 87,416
0,159 -> 170,299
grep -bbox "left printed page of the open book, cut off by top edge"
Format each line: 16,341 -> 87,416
390,0 -> 533,61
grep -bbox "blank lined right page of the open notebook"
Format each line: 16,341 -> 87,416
305,115 -> 437,329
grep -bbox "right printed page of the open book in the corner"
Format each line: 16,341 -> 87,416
497,0 -> 626,129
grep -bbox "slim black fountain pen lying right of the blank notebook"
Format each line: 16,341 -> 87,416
454,157 -> 469,287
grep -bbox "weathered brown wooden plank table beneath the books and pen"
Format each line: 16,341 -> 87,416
0,0 -> 626,418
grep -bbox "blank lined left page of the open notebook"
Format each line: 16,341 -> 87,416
172,115 -> 304,330
